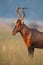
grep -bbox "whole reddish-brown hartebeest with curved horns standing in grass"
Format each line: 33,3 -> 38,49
12,8 -> 43,55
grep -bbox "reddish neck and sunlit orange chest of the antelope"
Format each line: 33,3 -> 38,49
20,24 -> 31,47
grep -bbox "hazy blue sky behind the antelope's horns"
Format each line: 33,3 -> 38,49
0,0 -> 43,21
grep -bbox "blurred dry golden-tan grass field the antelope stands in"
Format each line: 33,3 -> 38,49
0,26 -> 43,65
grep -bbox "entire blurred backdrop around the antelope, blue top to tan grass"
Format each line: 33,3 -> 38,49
0,0 -> 43,65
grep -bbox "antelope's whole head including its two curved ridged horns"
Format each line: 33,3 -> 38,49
12,8 -> 25,35
